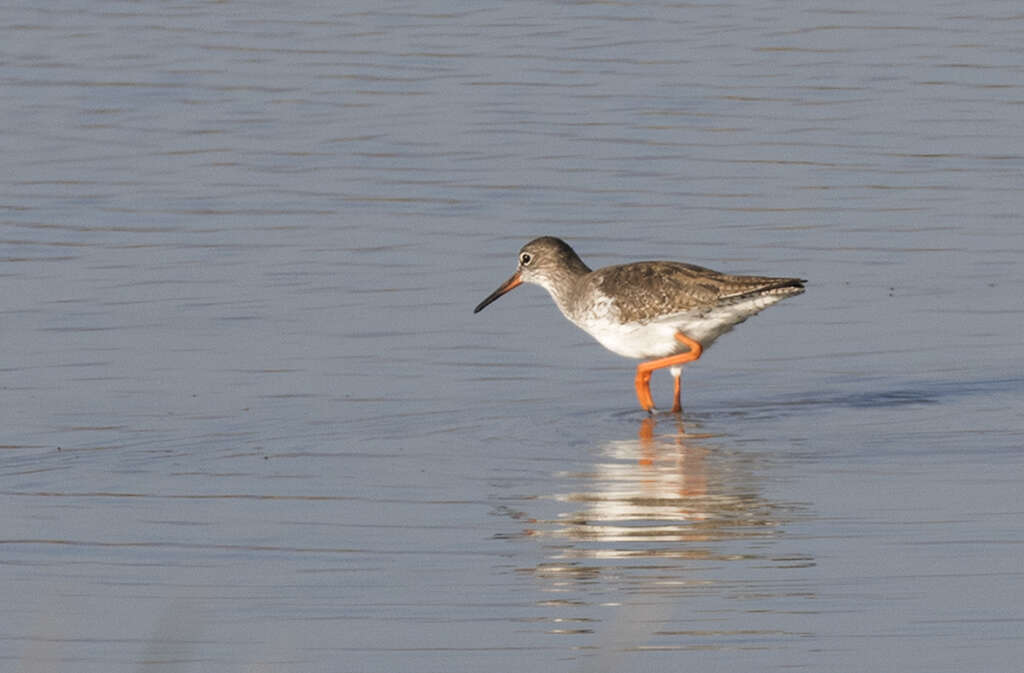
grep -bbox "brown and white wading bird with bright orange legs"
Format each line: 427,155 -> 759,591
473,236 -> 805,413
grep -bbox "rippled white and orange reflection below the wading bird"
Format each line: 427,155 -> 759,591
530,417 -> 794,579
